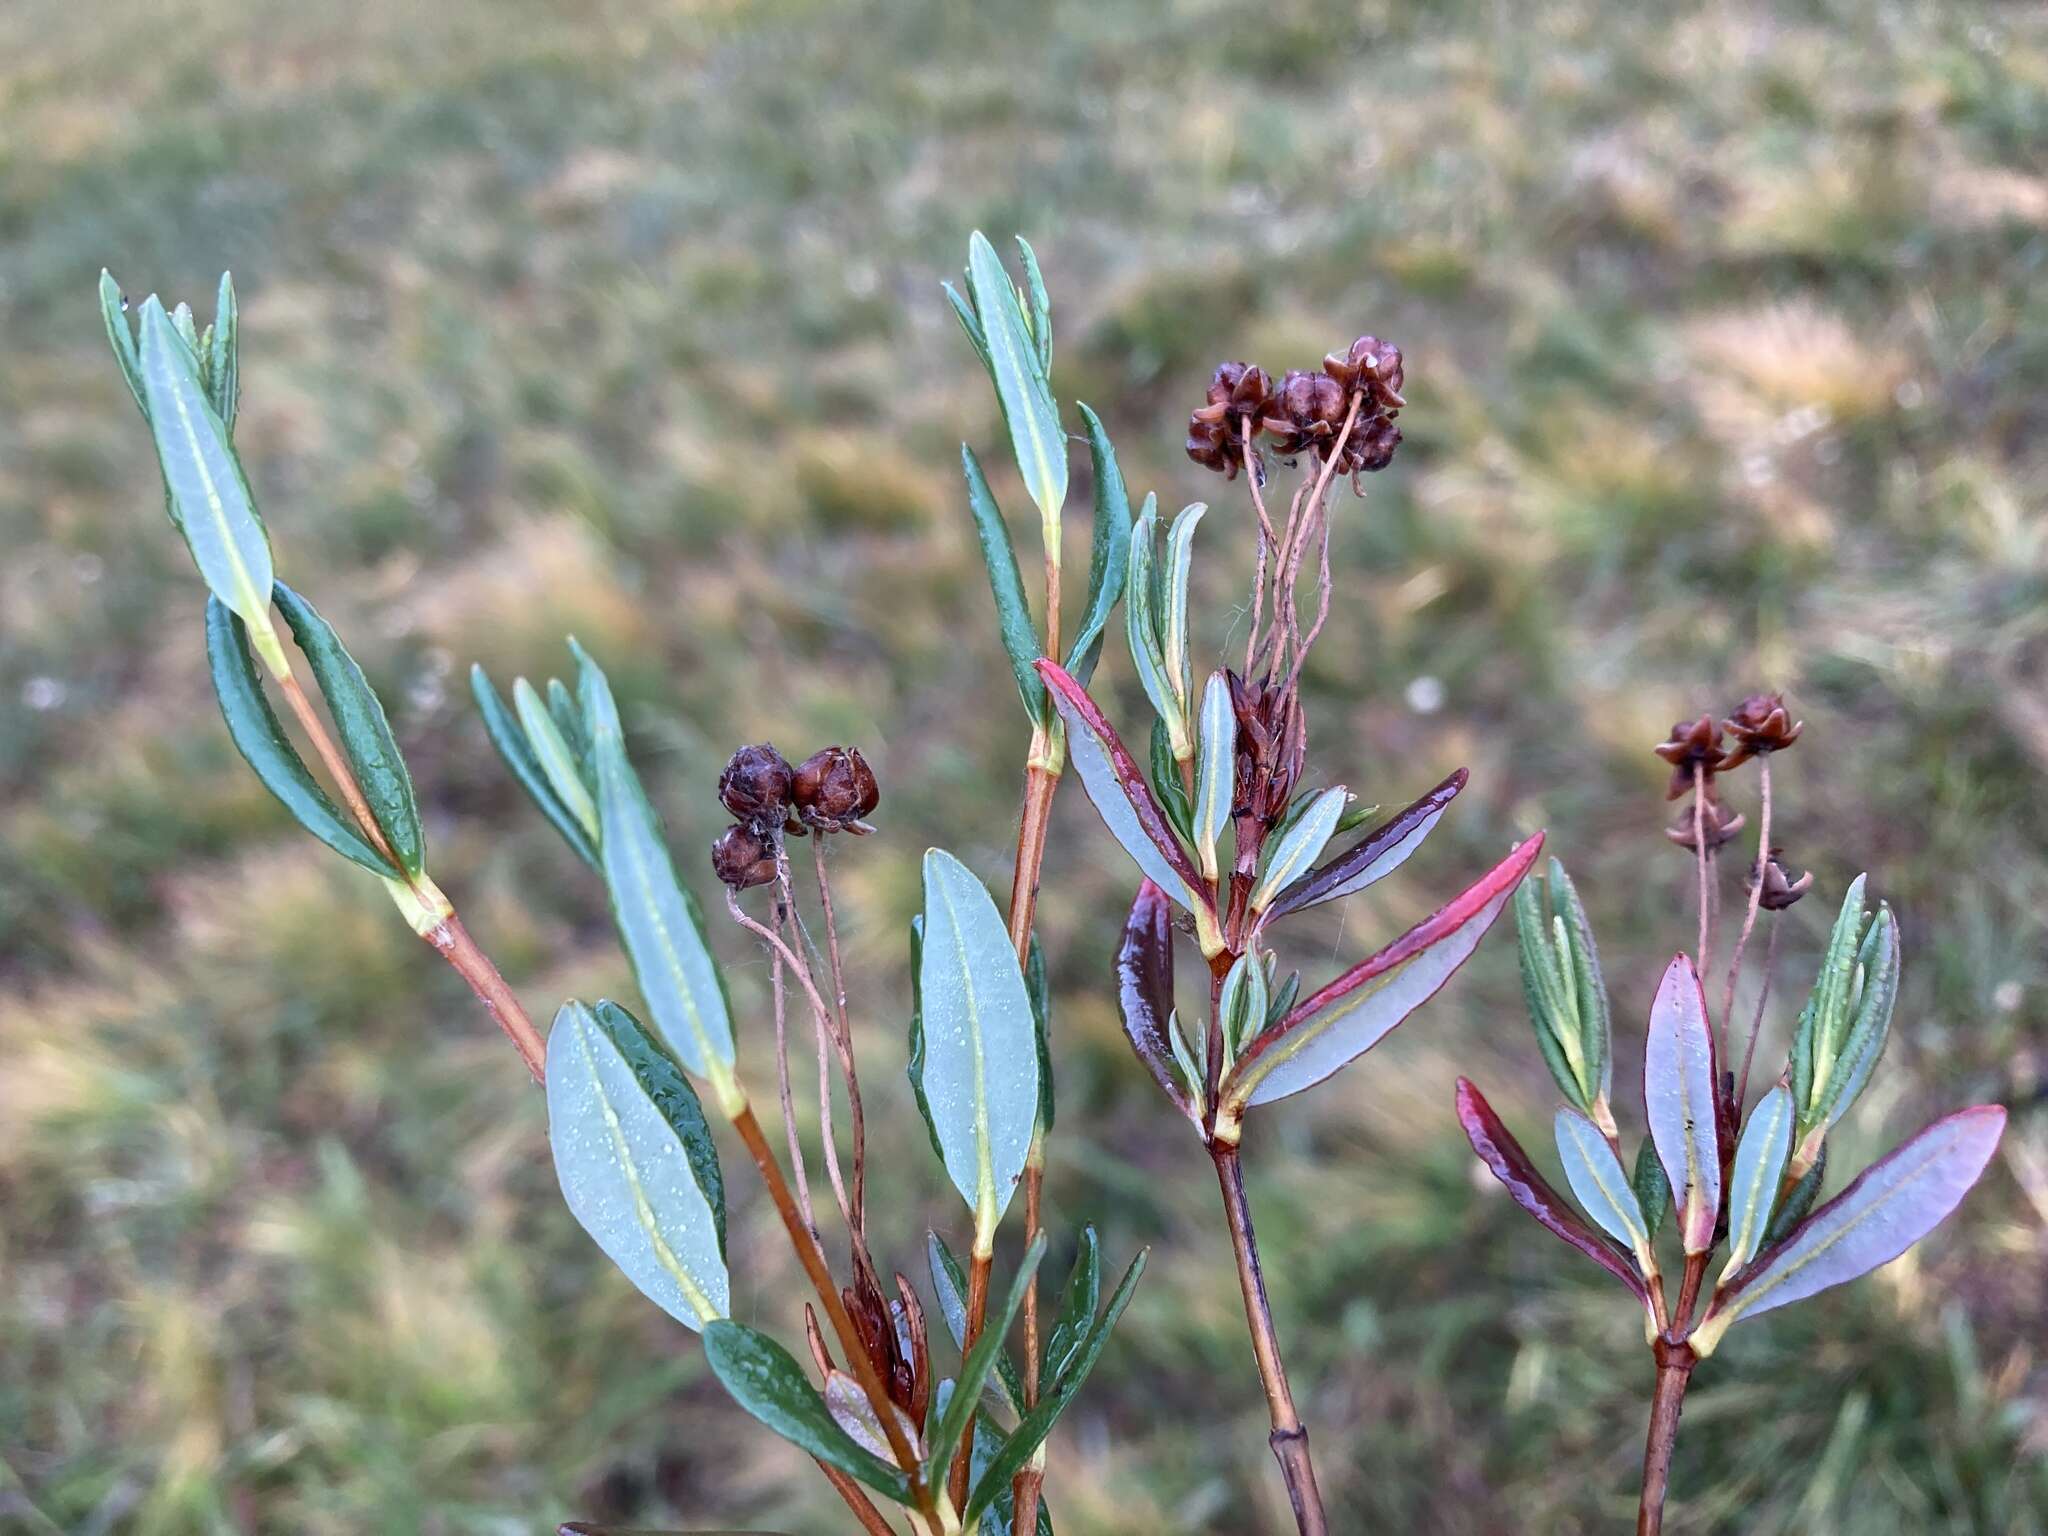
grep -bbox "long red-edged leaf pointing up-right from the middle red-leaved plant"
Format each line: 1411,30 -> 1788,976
1223,831 -> 1542,1106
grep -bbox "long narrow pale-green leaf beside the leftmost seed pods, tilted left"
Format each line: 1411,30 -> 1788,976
569,639 -> 733,1094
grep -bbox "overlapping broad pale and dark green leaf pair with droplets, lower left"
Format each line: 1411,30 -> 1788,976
547,1001 -> 729,1329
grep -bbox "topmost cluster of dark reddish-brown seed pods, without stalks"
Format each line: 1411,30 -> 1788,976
1188,336 -> 1407,479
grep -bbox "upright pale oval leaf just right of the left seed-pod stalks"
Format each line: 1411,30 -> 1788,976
918,848 -> 1038,1235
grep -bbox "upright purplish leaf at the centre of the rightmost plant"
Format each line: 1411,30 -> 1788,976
1642,954 -> 1720,1253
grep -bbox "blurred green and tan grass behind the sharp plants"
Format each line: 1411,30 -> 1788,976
0,0 -> 2048,1536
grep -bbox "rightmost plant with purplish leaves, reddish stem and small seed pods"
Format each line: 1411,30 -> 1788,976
1458,694 -> 2005,1536
